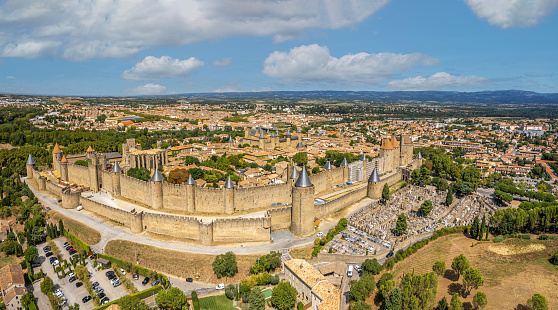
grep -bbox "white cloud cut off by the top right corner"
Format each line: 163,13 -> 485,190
465,0 -> 558,28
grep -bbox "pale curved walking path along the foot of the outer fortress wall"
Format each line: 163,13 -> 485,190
24,178 -> 372,255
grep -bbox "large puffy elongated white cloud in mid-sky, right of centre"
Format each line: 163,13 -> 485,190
263,44 -> 439,84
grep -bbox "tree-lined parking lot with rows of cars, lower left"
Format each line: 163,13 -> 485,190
33,237 -> 136,310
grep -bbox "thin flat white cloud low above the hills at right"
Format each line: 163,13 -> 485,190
388,72 -> 490,90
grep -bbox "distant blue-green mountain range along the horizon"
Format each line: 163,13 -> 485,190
166,90 -> 558,105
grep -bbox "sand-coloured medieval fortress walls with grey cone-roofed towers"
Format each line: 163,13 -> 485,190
27,135 -> 422,245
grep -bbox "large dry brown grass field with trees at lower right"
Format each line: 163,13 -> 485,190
376,234 -> 558,309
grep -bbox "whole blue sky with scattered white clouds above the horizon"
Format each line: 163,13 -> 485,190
0,0 -> 558,96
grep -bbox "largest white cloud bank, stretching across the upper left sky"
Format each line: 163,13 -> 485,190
0,0 -> 390,61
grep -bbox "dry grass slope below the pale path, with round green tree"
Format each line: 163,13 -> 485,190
105,240 -> 259,284
